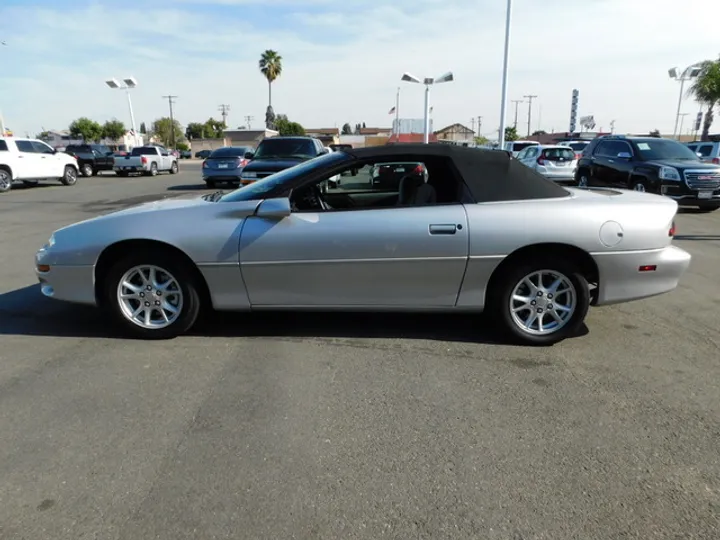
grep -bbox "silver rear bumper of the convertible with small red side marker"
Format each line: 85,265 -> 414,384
591,245 -> 692,306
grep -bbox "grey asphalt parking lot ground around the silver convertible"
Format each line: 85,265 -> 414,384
0,162 -> 720,540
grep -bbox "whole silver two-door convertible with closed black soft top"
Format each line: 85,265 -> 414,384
35,144 -> 690,344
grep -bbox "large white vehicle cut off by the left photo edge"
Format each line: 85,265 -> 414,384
0,137 -> 78,193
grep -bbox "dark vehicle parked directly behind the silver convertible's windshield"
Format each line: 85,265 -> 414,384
241,137 -> 329,184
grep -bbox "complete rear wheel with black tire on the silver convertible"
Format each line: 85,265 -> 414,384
491,257 -> 590,345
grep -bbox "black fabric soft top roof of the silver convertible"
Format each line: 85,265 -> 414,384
348,144 -> 568,202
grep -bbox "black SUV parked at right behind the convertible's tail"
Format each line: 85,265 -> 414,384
575,135 -> 720,210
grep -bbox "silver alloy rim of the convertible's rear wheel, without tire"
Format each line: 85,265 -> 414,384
510,269 -> 577,336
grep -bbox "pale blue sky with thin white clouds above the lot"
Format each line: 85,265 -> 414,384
0,0 -> 720,138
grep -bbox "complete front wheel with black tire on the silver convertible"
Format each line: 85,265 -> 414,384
104,252 -> 201,339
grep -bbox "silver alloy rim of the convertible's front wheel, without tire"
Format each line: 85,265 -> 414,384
117,265 -> 183,330
